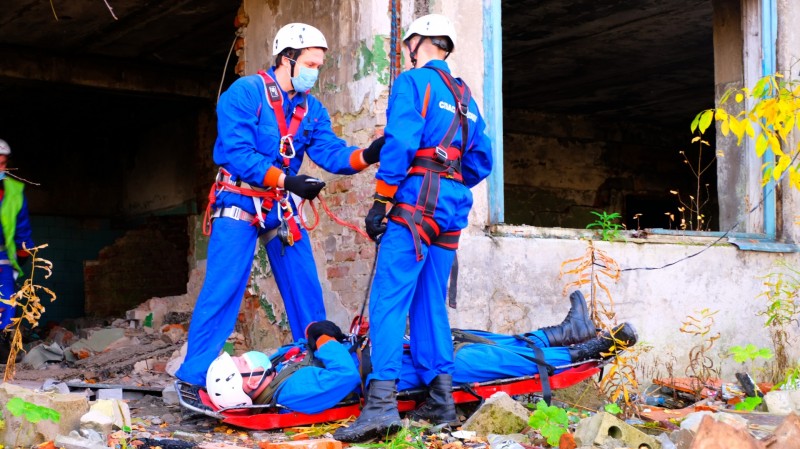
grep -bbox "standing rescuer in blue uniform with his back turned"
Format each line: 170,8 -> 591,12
334,14 -> 492,442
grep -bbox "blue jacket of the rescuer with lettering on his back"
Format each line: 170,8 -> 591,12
375,60 -> 492,231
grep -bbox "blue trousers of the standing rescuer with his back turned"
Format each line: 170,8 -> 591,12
369,221 -> 455,384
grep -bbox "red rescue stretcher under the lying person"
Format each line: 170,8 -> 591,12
175,359 -> 611,430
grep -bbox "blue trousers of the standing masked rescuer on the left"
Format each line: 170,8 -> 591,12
175,218 -> 325,386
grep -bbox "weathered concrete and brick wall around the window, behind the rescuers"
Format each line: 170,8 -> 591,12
222,0 -> 800,380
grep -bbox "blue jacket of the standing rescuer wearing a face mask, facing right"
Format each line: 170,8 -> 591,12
214,69 -> 365,227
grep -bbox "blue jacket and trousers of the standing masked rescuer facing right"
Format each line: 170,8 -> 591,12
176,68 -> 364,385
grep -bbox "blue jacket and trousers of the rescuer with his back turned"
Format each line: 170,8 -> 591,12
369,60 -> 492,384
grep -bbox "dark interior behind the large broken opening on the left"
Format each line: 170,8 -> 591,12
0,0 -> 241,323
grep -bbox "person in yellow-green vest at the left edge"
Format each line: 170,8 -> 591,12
0,140 -> 33,334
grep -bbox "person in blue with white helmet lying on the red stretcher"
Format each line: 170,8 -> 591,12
206,291 -> 638,418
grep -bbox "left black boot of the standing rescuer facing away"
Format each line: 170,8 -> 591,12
333,380 -> 403,443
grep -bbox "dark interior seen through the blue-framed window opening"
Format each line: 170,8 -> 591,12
502,0 -> 718,230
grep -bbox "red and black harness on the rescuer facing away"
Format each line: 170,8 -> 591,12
389,67 -> 471,261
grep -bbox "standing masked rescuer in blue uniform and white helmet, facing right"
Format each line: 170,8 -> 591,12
176,23 -> 383,385
